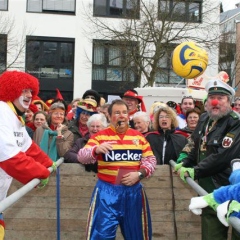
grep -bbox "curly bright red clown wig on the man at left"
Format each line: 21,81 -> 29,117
0,71 -> 39,102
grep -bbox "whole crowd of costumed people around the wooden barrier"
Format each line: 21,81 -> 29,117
0,71 -> 240,240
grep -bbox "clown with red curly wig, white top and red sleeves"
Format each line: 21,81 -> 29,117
0,71 -> 56,238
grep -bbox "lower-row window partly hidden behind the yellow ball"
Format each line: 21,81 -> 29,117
155,47 -> 182,86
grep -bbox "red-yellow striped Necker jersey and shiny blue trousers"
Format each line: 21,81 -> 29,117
78,126 -> 156,240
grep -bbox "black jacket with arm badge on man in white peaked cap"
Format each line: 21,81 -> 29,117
183,111 -> 240,188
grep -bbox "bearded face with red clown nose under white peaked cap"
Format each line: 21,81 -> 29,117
206,94 -> 232,120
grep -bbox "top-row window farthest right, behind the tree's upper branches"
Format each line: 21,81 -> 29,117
159,0 -> 202,22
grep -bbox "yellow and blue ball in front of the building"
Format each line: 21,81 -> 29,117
172,42 -> 208,79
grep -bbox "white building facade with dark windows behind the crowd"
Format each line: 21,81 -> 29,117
0,0 -> 219,101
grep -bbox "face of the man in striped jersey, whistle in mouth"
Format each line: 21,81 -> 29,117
110,104 -> 128,133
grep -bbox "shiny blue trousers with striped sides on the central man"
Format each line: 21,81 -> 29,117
86,180 -> 152,240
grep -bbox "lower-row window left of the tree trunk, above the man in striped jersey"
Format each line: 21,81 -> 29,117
92,40 -> 137,82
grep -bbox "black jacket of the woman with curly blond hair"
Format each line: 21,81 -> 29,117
145,128 -> 187,165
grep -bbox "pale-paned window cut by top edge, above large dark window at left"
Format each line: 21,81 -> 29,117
27,0 -> 76,14
